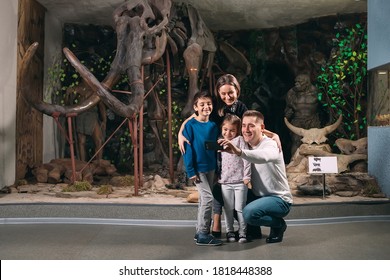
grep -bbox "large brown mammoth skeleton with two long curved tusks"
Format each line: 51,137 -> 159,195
21,0 -> 216,118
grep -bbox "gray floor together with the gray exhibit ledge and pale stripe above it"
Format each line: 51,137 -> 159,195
0,202 -> 390,260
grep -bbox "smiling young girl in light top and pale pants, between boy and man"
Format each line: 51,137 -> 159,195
218,114 -> 251,243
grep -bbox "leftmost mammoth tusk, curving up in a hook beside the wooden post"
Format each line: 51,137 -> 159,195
18,42 -> 100,116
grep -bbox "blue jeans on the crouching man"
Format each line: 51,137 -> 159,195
242,196 -> 291,228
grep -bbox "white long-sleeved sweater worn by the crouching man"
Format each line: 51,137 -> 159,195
241,136 -> 293,203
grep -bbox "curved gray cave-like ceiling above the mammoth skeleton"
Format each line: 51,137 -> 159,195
36,0 -> 367,31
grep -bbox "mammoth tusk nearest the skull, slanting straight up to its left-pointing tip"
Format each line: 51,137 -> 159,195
64,48 -> 143,118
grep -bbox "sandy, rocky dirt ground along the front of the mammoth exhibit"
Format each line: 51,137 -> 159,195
0,175 -> 388,204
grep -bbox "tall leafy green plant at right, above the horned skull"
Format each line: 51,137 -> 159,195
316,24 -> 367,139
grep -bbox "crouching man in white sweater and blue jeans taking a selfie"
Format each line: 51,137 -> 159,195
218,110 -> 293,243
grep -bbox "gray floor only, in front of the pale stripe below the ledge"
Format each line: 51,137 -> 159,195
0,220 -> 390,260
